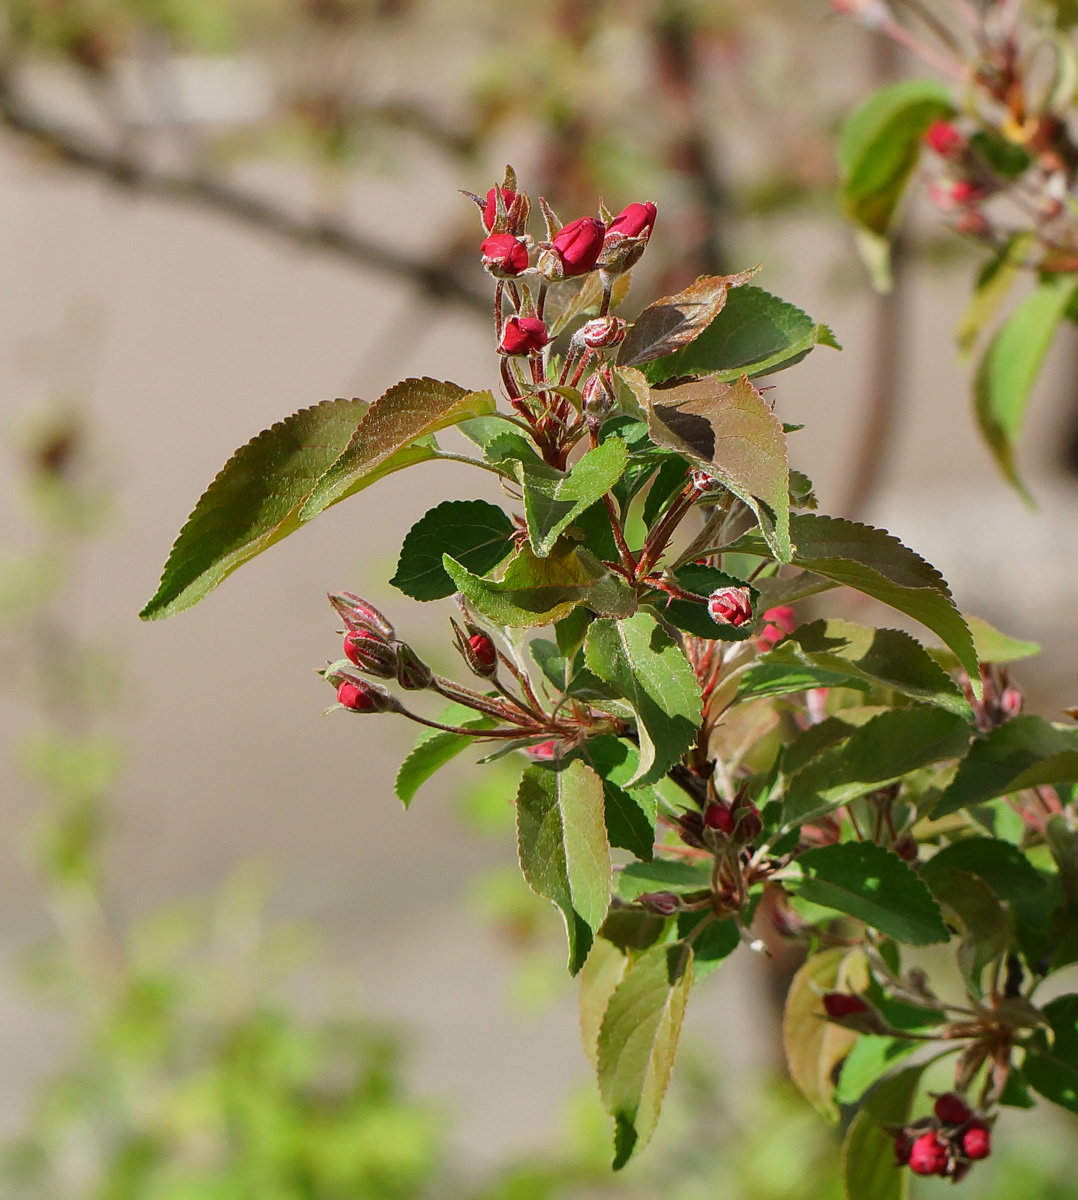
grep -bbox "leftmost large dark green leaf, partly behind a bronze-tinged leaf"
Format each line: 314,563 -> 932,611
139,400 -> 379,620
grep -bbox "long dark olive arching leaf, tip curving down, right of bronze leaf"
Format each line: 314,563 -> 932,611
724,512 -> 980,688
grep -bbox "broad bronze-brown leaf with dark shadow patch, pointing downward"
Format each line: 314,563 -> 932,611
648,376 -> 791,563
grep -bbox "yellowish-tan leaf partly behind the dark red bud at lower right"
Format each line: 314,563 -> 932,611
783,947 -> 868,1123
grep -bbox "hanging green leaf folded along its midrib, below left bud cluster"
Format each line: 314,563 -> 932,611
516,760 -> 610,974
